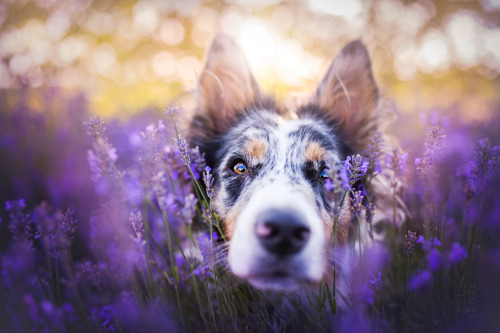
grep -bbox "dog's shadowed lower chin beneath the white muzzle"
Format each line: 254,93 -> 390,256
247,272 -> 315,292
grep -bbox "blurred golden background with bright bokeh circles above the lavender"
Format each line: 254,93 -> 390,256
0,0 -> 500,121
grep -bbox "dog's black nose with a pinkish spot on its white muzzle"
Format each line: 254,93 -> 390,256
255,210 -> 311,256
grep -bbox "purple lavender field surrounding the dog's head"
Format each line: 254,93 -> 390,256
0,91 -> 500,332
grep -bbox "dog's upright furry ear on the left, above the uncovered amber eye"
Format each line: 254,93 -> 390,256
190,34 -> 260,141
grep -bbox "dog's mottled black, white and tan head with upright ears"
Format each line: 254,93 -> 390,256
190,35 -> 378,290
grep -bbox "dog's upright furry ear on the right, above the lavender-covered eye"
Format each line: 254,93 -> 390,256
313,41 -> 378,151
